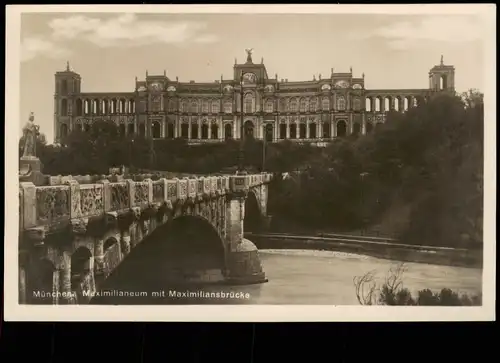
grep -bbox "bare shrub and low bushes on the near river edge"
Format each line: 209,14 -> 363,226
354,264 -> 482,306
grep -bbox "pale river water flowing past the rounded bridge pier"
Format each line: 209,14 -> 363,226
95,250 -> 482,305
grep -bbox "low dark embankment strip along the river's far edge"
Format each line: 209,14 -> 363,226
245,233 -> 483,268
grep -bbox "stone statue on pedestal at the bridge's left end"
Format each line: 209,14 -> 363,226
19,112 -> 45,185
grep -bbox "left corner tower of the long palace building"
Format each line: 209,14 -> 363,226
54,62 -> 82,143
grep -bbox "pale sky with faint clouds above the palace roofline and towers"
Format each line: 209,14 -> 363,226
20,13 -> 484,142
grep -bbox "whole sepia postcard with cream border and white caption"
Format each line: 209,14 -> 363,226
5,5 -> 496,321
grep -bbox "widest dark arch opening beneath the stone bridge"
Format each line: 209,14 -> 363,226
92,214 -> 226,304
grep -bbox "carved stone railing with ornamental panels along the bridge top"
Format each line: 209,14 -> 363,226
19,173 -> 272,230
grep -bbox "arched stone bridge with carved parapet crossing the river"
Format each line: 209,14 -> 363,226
19,173 -> 272,304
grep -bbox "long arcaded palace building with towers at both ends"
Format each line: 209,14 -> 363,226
54,50 -> 455,145
